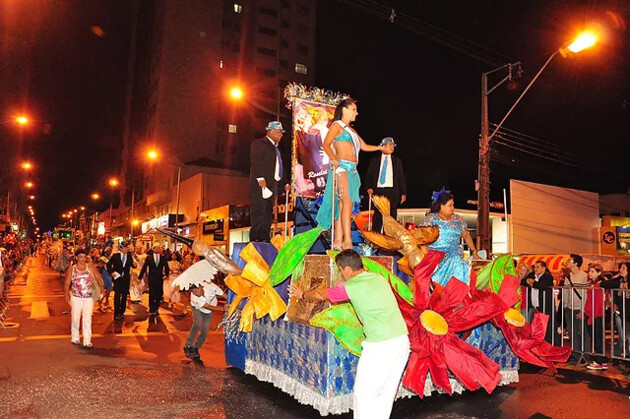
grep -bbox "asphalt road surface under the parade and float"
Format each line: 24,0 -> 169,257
0,256 -> 630,419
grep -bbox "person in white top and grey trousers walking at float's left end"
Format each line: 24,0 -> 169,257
184,282 -> 223,366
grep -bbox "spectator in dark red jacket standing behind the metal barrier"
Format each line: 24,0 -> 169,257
584,263 -> 608,371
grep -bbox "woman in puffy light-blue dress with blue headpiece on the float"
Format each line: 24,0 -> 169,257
422,189 -> 477,286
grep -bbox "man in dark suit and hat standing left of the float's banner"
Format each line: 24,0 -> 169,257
249,121 -> 284,242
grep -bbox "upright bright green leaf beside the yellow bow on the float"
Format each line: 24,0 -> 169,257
269,226 -> 323,287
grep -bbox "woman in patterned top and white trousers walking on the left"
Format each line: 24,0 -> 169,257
63,249 -> 103,348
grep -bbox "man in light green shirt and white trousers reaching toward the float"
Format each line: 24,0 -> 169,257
289,249 -> 409,419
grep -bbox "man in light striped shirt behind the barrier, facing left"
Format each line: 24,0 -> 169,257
562,254 -> 590,360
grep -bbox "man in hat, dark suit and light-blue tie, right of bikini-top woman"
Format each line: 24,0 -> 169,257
365,137 -> 407,233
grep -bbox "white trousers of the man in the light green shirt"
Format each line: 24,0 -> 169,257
354,335 -> 409,419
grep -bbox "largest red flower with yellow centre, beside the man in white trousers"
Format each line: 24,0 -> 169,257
394,251 -> 505,397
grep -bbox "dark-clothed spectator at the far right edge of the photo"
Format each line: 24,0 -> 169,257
601,262 -> 630,357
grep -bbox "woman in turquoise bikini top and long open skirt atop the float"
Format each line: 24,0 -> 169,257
317,98 -> 383,250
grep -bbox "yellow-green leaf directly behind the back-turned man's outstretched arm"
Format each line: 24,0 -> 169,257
309,303 -> 365,356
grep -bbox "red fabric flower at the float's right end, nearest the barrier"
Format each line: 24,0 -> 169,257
471,275 -> 571,371
